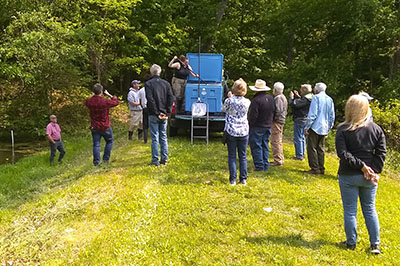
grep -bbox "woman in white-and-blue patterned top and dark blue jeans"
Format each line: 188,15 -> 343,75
223,79 -> 250,186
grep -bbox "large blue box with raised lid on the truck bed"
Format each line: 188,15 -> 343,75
169,53 -> 225,136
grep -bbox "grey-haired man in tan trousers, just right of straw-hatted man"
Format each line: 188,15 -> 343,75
271,82 -> 288,166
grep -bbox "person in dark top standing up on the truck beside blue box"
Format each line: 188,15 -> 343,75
168,55 -> 199,113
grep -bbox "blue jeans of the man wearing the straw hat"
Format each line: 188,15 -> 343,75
249,127 -> 271,171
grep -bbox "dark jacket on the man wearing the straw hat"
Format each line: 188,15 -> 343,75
248,91 -> 275,128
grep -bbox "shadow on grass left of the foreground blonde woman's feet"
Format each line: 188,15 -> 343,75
243,234 -> 344,250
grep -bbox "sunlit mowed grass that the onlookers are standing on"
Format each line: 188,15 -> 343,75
0,136 -> 400,265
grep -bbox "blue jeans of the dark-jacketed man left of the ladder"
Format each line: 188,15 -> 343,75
149,115 -> 168,164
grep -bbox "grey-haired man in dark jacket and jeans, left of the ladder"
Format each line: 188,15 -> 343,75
145,64 -> 175,166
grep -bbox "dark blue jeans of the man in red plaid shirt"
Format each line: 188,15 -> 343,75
92,127 -> 114,166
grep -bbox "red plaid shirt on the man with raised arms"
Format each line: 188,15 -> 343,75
85,95 -> 119,131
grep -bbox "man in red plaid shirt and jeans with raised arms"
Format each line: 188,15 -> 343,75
85,83 -> 119,166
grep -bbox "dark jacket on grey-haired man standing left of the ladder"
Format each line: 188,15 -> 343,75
144,76 -> 175,116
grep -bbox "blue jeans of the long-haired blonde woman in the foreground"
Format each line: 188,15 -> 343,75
339,174 -> 379,245
